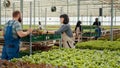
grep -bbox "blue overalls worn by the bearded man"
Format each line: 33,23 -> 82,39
1,21 -> 20,60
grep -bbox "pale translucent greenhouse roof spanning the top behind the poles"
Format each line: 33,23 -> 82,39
1,0 -> 120,17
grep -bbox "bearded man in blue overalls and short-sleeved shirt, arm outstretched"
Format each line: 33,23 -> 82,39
1,11 -> 32,60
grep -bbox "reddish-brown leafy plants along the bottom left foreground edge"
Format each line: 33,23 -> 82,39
0,60 -> 66,68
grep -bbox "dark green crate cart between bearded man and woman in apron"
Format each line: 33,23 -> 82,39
21,34 -> 61,54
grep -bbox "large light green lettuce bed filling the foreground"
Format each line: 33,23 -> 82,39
11,49 -> 120,68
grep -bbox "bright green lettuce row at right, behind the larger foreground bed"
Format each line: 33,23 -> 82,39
76,40 -> 120,50
